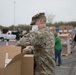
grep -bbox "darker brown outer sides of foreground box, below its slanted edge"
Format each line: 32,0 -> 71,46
5,55 -> 34,75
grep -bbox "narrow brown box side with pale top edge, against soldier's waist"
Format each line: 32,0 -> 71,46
21,55 -> 34,75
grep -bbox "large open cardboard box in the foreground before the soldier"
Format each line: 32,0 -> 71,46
0,46 -> 34,75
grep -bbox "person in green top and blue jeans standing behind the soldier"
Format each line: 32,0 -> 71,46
54,32 -> 62,66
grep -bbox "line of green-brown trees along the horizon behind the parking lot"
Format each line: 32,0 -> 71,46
0,21 -> 76,30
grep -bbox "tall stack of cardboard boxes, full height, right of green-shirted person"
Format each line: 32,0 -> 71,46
59,25 -> 72,55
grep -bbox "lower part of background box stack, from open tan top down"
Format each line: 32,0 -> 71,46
59,34 -> 72,55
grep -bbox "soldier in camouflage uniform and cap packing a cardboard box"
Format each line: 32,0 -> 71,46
17,13 -> 55,75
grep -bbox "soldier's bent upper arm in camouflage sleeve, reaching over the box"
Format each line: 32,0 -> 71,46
17,32 -> 38,47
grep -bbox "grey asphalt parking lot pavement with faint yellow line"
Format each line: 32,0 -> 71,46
0,41 -> 76,75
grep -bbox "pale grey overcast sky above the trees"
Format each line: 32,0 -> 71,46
0,0 -> 76,26
